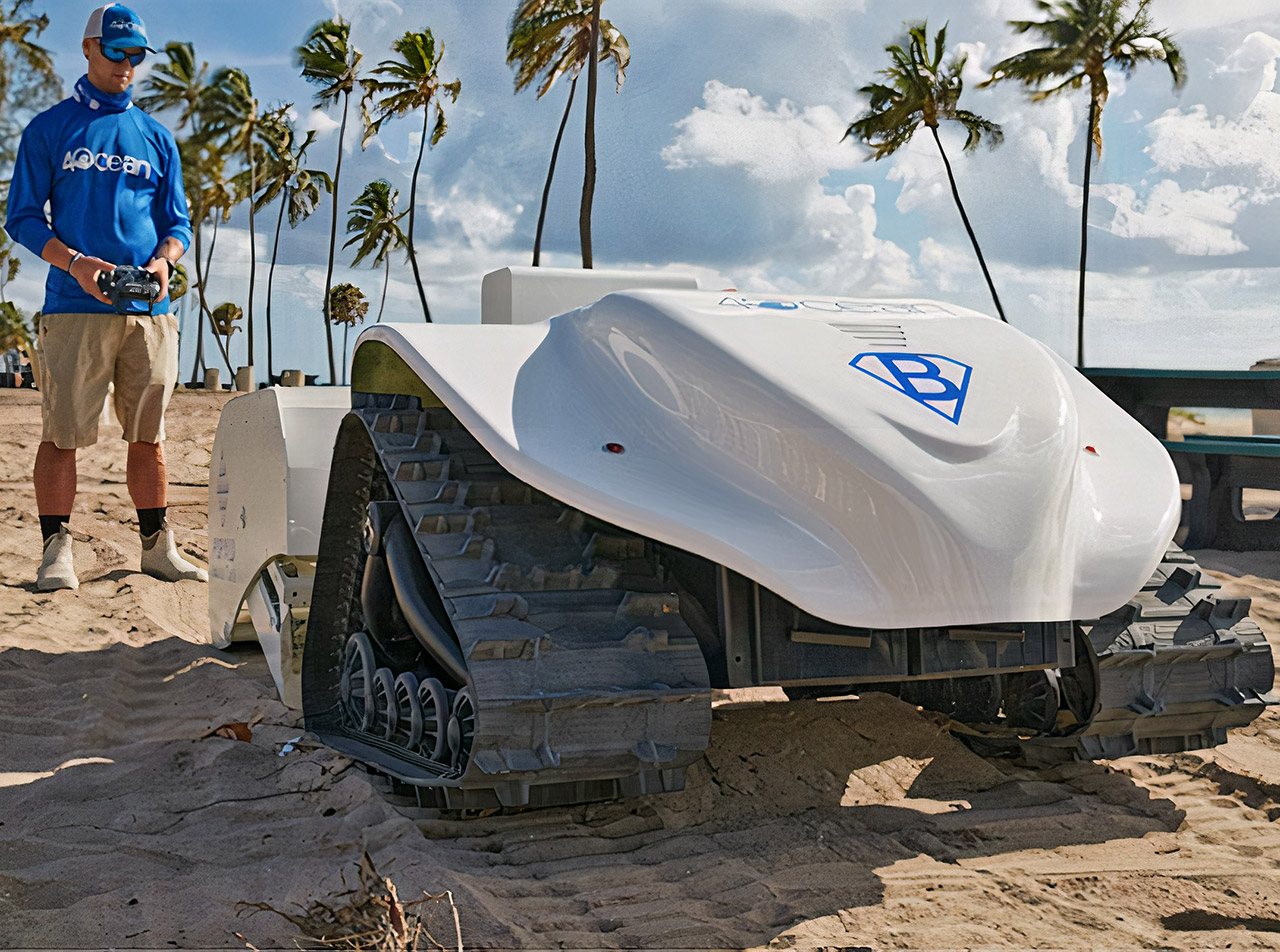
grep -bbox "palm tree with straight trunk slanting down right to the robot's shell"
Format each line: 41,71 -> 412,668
845,20 -> 1007,322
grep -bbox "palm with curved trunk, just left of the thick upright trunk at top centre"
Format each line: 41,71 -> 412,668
507,0 -> 631,267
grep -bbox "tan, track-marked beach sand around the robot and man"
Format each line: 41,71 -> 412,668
0,392 -> 1280,949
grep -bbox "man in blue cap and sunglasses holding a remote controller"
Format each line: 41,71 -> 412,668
5,4 -> 209,591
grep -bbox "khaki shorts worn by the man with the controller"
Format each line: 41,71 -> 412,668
38,313 -> 178,449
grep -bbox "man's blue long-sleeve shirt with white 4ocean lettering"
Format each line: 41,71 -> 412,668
5,77 -> 192,313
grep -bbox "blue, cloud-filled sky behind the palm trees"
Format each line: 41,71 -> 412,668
10,0 -> 1280,377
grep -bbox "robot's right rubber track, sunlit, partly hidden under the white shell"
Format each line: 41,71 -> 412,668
1021,545 -> 1275,763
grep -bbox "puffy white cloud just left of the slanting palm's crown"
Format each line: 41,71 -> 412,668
662,79 -> 863,183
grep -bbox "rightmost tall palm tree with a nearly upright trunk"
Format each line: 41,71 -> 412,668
982,0 -> 1187,367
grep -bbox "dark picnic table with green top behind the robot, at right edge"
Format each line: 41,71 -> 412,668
1080,367 -> 1280,551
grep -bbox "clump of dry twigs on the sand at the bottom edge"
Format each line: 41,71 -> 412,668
233,851 -> 463,952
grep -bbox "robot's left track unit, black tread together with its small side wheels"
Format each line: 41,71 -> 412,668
303,395 -> 710,809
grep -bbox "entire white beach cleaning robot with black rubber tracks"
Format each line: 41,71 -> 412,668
210,269 -> 1274,809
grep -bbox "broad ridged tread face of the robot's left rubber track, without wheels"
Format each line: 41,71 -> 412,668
335,397 -> 710,807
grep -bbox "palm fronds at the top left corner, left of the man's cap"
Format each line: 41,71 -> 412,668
0,0 -> 63,184
